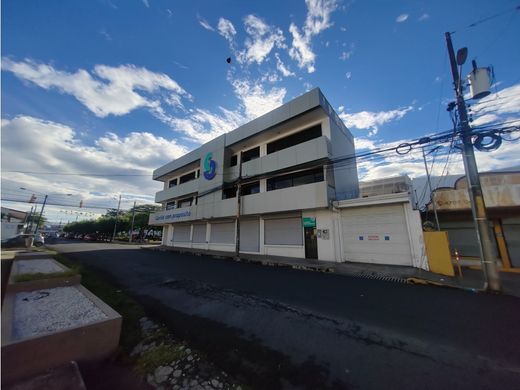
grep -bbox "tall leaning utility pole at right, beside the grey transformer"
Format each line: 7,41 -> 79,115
445,32 -> 500,291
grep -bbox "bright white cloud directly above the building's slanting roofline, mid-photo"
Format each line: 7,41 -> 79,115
231,80 -> 287,119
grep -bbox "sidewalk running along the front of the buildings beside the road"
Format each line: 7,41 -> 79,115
143,245 -> 520,297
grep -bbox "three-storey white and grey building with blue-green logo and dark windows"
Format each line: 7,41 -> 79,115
150,89 -> 359,260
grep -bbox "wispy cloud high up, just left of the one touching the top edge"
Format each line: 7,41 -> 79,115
238,15 -> 285,64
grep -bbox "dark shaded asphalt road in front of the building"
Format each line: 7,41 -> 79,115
50,242 -> 520,389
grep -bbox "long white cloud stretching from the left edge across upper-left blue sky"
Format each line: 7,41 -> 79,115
2,57 -> 191,117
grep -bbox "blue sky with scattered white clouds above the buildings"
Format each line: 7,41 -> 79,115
1,0 -> 520,223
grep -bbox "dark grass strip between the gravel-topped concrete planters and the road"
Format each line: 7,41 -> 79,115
54,254 -> 145,355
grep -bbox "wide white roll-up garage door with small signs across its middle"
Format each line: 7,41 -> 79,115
341,204 -> 413,266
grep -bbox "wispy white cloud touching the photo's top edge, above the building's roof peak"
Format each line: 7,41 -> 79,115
289,0 -> 337,73
